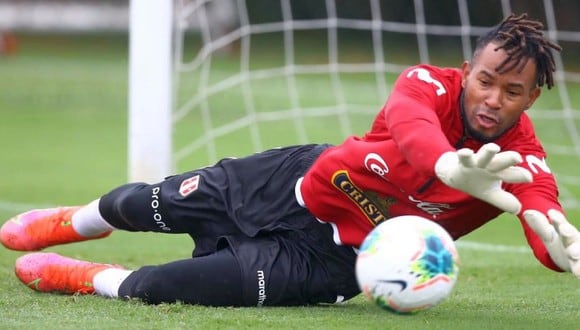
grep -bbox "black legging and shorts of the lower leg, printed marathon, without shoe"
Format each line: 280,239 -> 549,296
125,222 -> 360,307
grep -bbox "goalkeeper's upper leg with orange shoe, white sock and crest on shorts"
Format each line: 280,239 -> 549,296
0,145 -> 326,256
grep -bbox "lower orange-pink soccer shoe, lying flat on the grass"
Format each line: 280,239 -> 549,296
14,252 -> 123,294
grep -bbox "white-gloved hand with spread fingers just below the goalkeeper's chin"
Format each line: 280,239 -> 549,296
435,143 -> 532,214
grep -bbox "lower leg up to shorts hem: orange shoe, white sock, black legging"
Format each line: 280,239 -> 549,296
15,249 -> 242,306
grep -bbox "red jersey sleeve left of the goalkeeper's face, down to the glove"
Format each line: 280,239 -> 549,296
366,66 -> 463,177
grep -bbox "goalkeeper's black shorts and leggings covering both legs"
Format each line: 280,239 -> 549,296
99,145 -> 359,306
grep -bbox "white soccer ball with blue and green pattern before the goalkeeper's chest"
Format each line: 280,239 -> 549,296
356,216 -> 459,314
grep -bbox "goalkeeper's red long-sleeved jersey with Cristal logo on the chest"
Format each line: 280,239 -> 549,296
299,65 -> 562,270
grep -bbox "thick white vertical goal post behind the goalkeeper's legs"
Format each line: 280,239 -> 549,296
128,0 -> 174,182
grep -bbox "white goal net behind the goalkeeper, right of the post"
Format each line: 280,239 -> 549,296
129,0 -> 580,208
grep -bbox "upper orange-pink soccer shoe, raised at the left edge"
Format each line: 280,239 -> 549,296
0,206 -> 111,251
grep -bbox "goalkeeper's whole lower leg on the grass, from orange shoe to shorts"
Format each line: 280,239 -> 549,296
16,224 -> 359,306
